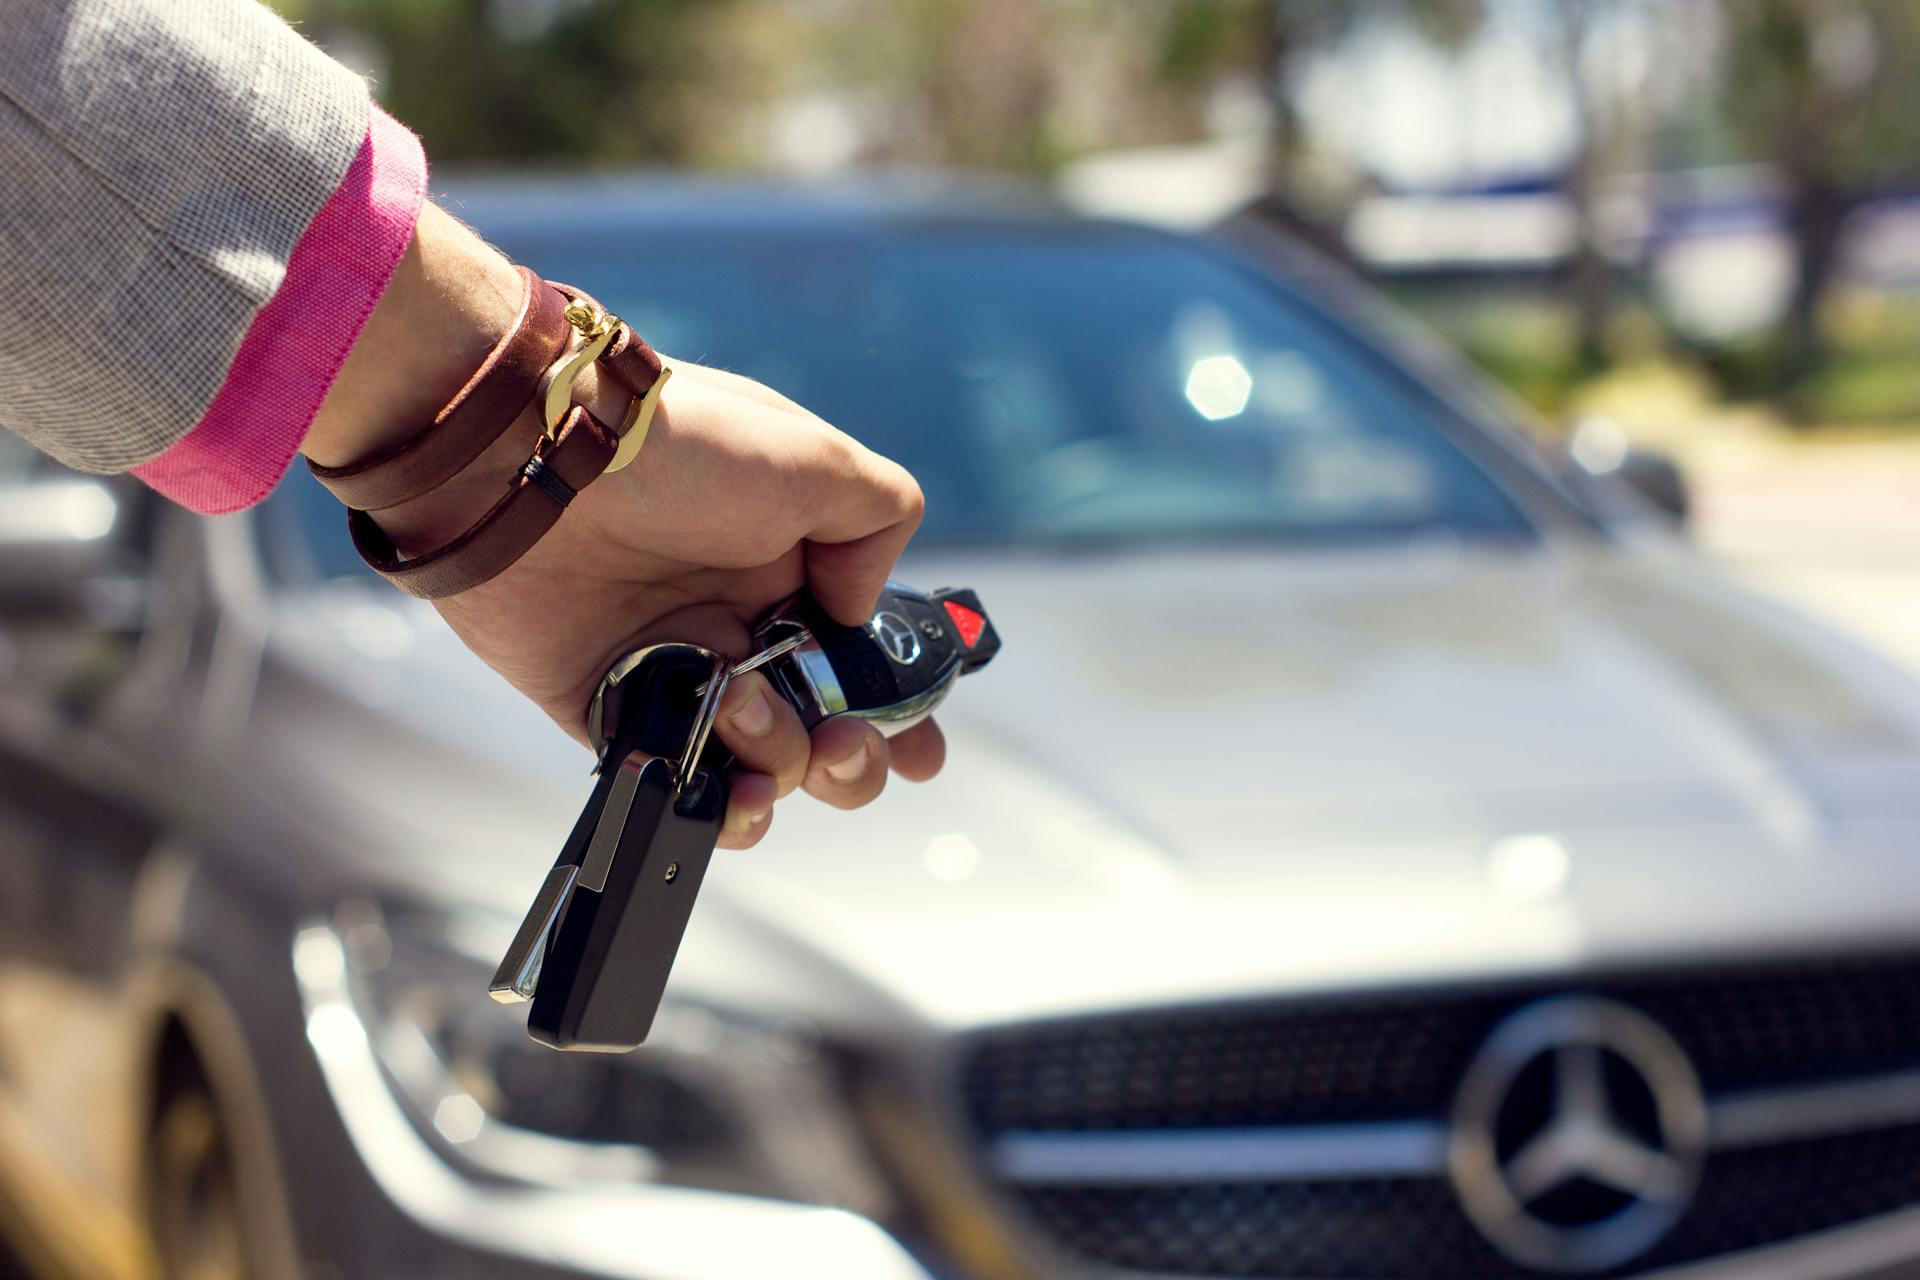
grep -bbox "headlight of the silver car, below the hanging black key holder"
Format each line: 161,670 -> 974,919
294,904 -> 893,1219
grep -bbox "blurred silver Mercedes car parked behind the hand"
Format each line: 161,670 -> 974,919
0,180 -> 1920,1280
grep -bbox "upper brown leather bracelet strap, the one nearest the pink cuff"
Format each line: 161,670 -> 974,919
307,267 -> 574,510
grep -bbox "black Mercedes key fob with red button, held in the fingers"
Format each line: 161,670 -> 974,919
753,581 -> 1000,735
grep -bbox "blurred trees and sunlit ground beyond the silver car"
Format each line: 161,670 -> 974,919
275,0 -> 1920,660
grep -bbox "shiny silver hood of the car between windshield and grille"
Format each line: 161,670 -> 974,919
259,543 -> 1920,1023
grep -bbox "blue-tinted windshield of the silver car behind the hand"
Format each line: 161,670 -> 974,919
266,223 -> 1528,572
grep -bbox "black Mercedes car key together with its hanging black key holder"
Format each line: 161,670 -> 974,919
492,583 -> 1000,1052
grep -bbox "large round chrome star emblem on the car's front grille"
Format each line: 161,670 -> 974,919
1448,996 -> 1707,1270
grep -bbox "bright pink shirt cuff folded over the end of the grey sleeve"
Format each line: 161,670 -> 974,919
132,107 -> 426,516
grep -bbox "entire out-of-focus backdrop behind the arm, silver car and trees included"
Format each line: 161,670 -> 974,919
11,0 -> 1920,1280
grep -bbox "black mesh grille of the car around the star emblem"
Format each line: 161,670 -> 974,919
962,956 -> 1920,1280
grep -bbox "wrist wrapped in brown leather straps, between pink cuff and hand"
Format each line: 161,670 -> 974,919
303,226 -> 666,599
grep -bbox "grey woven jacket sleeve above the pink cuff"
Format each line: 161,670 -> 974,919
0,0 -> 369,472
